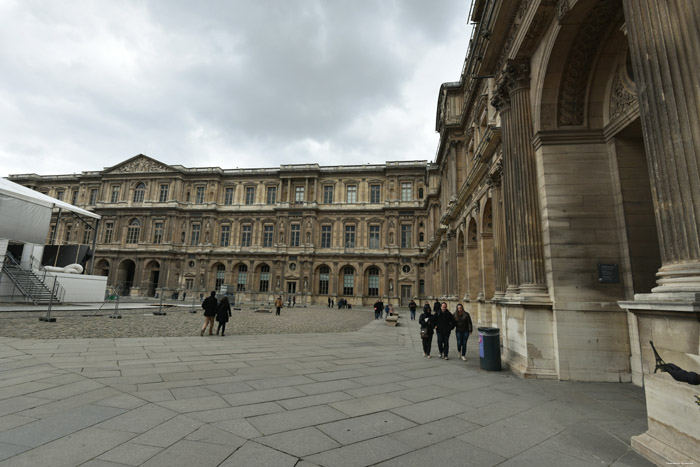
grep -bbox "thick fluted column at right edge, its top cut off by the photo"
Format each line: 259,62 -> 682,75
623,0 -> 700,293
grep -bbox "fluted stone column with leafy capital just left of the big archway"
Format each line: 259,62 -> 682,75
505,58 -> 547,295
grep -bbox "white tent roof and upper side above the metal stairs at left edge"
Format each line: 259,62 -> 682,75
0,178 -> 100,244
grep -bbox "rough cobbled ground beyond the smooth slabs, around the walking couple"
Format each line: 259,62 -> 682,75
0,307 -> 374,339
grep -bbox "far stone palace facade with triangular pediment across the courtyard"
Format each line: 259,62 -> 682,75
10,155 -> 429,305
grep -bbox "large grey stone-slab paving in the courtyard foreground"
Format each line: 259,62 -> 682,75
0,310 -> 651,467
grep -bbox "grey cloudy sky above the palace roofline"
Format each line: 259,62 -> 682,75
0,0 -> 471,176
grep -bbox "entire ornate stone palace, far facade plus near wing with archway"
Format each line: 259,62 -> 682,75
6,0 -> 700,465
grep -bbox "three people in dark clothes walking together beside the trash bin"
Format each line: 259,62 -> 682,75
418,301 -> 473,361
